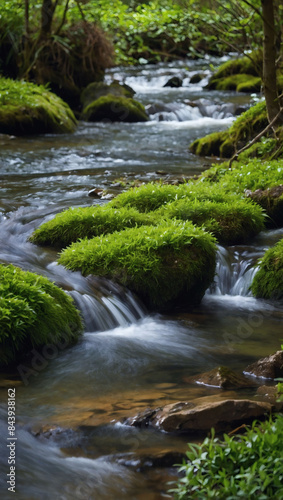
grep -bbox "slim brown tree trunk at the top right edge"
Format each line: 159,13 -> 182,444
261,0 -> 280,122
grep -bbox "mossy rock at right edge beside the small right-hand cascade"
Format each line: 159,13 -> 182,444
251,239 -> 283,299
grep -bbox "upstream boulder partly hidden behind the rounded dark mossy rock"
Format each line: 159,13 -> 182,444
81,80 -> 135,109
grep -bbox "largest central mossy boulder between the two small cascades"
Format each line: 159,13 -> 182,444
59,221 -> 216,311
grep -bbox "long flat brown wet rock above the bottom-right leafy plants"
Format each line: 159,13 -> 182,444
124,398 -> 272,433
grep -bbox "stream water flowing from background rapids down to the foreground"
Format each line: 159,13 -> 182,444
0,60 -> 283,500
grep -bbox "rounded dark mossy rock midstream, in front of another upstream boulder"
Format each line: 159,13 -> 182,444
82,94 -> 149,123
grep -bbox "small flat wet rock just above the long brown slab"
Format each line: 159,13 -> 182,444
185,366 -> 255,389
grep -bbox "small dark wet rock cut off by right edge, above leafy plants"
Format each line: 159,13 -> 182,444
244,351 -> 283,379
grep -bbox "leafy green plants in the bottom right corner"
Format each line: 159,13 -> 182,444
173,415 -> 283,500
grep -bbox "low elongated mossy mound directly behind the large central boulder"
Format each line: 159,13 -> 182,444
30,205 -> 161,248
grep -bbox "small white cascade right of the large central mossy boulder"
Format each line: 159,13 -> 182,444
211,246 -> 258,296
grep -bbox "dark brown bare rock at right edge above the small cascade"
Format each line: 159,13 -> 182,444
245,184 -> 283,227
